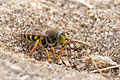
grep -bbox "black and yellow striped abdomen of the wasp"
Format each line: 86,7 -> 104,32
21,28 -> 40,41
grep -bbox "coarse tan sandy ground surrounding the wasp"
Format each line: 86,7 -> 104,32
0,0 -> 120,80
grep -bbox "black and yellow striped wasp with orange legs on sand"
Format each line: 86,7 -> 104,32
21,27 -> 69,62
